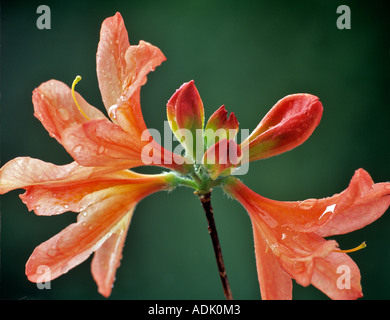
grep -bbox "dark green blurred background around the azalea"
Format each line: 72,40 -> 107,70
0,0 -> 390,299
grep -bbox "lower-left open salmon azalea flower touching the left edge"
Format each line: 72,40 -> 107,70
0,157 -> 173,297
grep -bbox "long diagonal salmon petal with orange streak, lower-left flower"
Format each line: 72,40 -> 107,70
26,187 -> 134,282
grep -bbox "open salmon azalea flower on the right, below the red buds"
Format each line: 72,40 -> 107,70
224,169 -> 390,299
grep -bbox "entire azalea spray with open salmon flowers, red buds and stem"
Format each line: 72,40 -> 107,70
0,13 -> 390,299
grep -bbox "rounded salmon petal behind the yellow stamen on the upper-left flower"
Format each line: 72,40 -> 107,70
32,80 -> 105,143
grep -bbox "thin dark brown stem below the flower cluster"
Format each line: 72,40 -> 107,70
197,191 -> 233,300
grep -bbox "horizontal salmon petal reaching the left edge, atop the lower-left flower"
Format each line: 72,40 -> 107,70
0,157 -> 166,215
